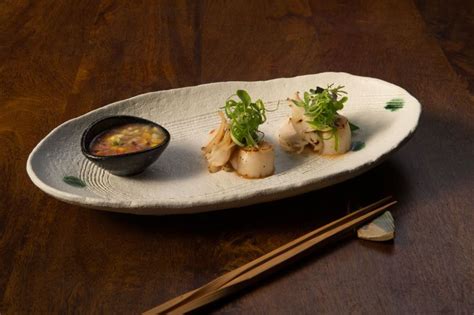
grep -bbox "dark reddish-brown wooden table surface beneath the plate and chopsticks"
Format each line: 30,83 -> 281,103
0,0 -> 474,314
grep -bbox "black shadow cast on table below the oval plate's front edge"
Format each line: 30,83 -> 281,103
100,160 -> 410,246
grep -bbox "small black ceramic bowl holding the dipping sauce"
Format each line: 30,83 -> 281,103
81,116 -> 170,176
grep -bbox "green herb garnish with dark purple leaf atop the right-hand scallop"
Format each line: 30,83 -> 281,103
291,84 -> 348,132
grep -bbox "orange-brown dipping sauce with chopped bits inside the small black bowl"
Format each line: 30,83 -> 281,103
90,123 -> 166,156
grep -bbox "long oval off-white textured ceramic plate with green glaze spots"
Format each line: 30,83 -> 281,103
27,72 -> 421,215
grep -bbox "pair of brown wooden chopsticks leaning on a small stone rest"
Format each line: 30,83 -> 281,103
143,197 -> 397,315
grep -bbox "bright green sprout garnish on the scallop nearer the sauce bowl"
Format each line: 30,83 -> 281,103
223,90 -> 267,147
